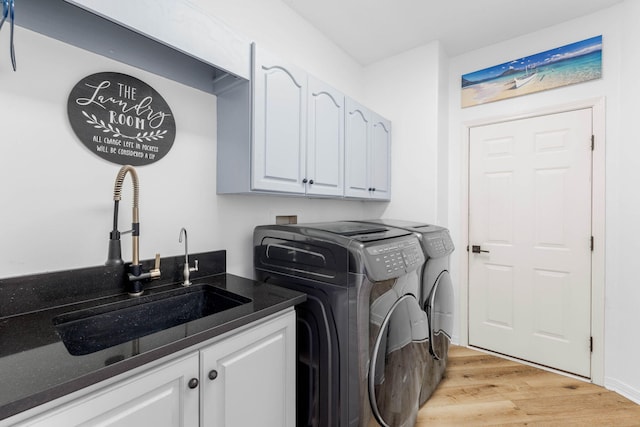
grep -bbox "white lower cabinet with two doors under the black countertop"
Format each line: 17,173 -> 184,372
10,310 -> 296,427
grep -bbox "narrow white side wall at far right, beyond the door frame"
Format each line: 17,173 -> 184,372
605,0 -> 640,403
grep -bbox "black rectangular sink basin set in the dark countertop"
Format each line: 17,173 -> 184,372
53,285 -> 251,356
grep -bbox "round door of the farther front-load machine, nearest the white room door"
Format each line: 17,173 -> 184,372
426,270 -> 454,360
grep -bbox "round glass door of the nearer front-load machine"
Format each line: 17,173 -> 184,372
368,289 -> 431,427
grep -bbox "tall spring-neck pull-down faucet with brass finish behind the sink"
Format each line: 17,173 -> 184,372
106,165 -> 160,296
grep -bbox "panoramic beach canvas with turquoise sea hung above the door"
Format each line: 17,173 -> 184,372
462,35 -> 602,108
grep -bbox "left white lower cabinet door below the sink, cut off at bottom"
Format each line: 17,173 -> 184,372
19,353 -> 199,427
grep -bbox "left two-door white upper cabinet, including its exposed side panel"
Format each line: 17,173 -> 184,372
217,48 -> 345,197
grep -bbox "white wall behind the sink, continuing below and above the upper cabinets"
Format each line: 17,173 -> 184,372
0,0 -> 386,278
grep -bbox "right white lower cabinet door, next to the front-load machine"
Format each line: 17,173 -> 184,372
200,311 -> 296,427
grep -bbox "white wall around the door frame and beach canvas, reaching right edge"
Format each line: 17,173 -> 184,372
449,0 -> 640,402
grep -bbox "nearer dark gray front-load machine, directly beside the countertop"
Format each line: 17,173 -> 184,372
254,222 -> 432,427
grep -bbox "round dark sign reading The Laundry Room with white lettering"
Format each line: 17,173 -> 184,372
67,72 -> 176,166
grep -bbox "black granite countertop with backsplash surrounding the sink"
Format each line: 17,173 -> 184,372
0,251 -> 306,420
